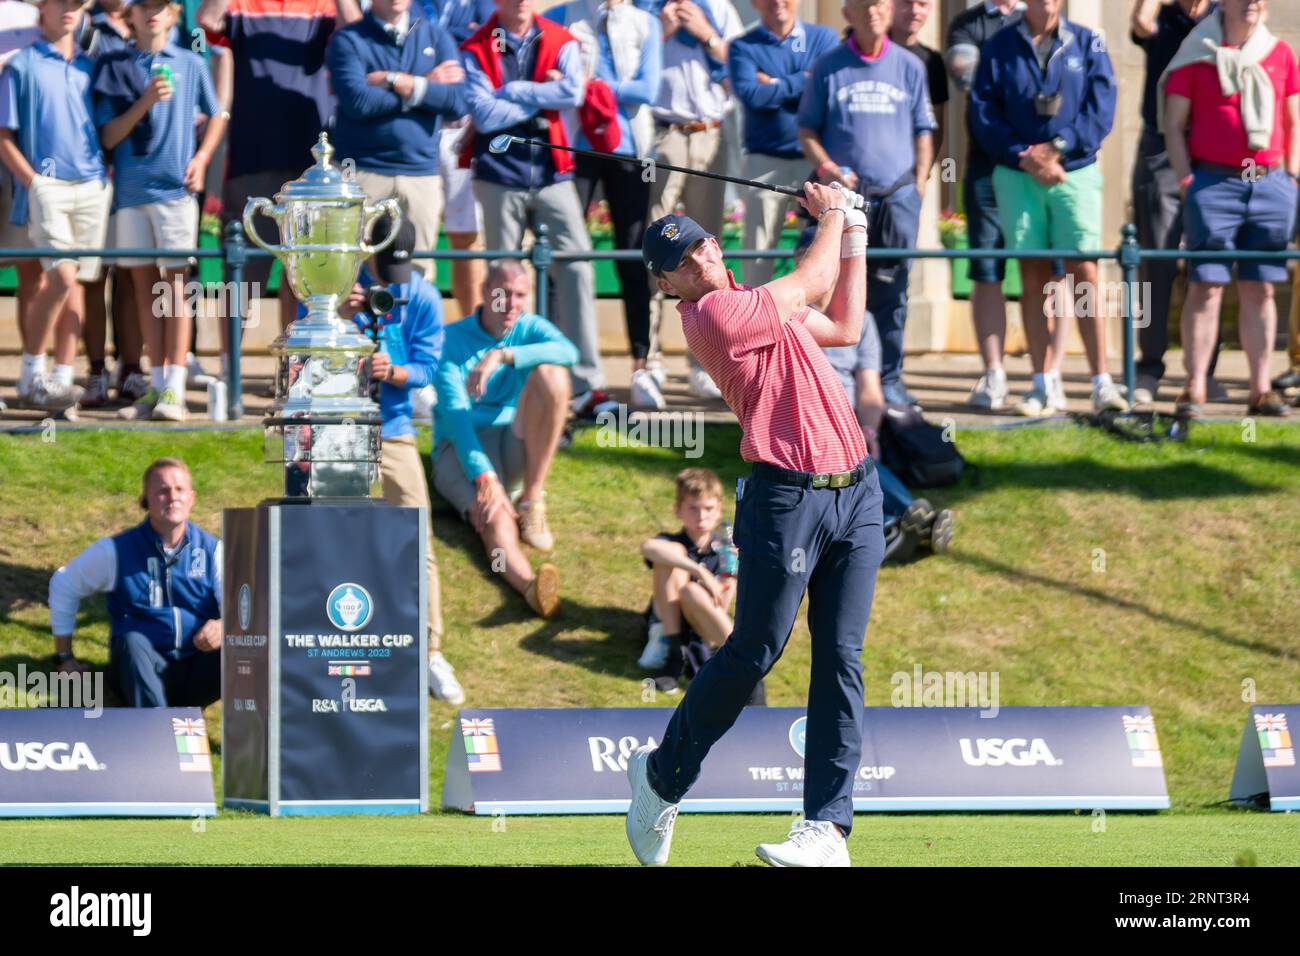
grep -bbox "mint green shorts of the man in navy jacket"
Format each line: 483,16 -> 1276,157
993,163 -> 1102,250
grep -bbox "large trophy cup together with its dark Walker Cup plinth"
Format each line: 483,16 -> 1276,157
221,133 -> 429,817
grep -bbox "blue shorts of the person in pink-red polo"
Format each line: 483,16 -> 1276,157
1183,169 -> 1296,285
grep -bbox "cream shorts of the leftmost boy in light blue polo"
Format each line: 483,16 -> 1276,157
27,173 -> 113,282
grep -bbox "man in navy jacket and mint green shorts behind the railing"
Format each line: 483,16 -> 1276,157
971,0 -> 1127,416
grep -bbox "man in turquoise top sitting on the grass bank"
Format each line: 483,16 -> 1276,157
433,259 -> 577,618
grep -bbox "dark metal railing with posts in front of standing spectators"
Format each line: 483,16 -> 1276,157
0,221 -> 1300,420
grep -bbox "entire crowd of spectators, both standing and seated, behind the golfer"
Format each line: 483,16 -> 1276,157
35,0 -> 1300,704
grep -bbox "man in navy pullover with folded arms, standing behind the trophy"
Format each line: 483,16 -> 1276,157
325,0 -> 467,274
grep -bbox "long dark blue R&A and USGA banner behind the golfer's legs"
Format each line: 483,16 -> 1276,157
442,706 -> 1169,814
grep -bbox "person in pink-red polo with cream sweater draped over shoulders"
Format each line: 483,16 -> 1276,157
1161,0 -> 1300,416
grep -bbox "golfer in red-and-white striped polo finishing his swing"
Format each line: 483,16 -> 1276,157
627,183 -> 884,866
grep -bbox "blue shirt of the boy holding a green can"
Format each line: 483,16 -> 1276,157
94,43 -> 221,209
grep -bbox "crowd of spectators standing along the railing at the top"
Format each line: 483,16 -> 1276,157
0,0 -> 1300,420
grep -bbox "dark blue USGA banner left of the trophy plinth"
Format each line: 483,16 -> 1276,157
0,708 -> 217,817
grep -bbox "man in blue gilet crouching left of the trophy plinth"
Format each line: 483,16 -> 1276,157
49,458 -> 222,708
